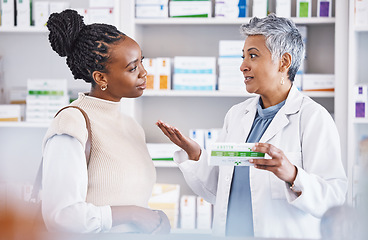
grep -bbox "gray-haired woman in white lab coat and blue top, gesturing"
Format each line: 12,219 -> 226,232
157,15 -> 347,238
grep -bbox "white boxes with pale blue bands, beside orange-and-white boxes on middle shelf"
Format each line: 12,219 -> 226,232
173,57 -> 216,91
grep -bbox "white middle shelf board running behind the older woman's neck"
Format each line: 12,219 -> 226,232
142,90 -> 335,98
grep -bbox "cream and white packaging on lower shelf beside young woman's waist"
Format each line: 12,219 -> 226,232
148,183 -> 180,229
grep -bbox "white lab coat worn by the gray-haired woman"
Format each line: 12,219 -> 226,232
174,86 -> 347,239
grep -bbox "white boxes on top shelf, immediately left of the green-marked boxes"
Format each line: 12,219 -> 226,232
135,0 -> 169,18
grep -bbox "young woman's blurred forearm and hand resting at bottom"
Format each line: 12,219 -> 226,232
111,206 -> 162,233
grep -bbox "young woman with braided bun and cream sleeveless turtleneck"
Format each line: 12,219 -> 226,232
42,10 -> 170,233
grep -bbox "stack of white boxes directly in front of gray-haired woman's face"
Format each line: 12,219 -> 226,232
218,40 -> 246,92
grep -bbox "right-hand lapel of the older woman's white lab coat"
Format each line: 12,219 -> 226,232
260,85 -> 303,142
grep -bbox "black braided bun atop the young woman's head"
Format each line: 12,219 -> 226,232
47,9 -> 85,57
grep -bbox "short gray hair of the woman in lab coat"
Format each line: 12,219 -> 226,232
241,14 -> 305,81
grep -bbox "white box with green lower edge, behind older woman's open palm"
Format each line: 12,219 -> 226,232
147,143 -> 180,161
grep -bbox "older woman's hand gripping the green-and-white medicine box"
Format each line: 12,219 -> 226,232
249,143 -> 298,184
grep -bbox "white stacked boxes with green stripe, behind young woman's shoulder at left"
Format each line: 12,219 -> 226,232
26,79 -> 69,122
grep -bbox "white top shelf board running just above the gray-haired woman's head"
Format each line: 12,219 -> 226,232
135,17 -> 335,25
